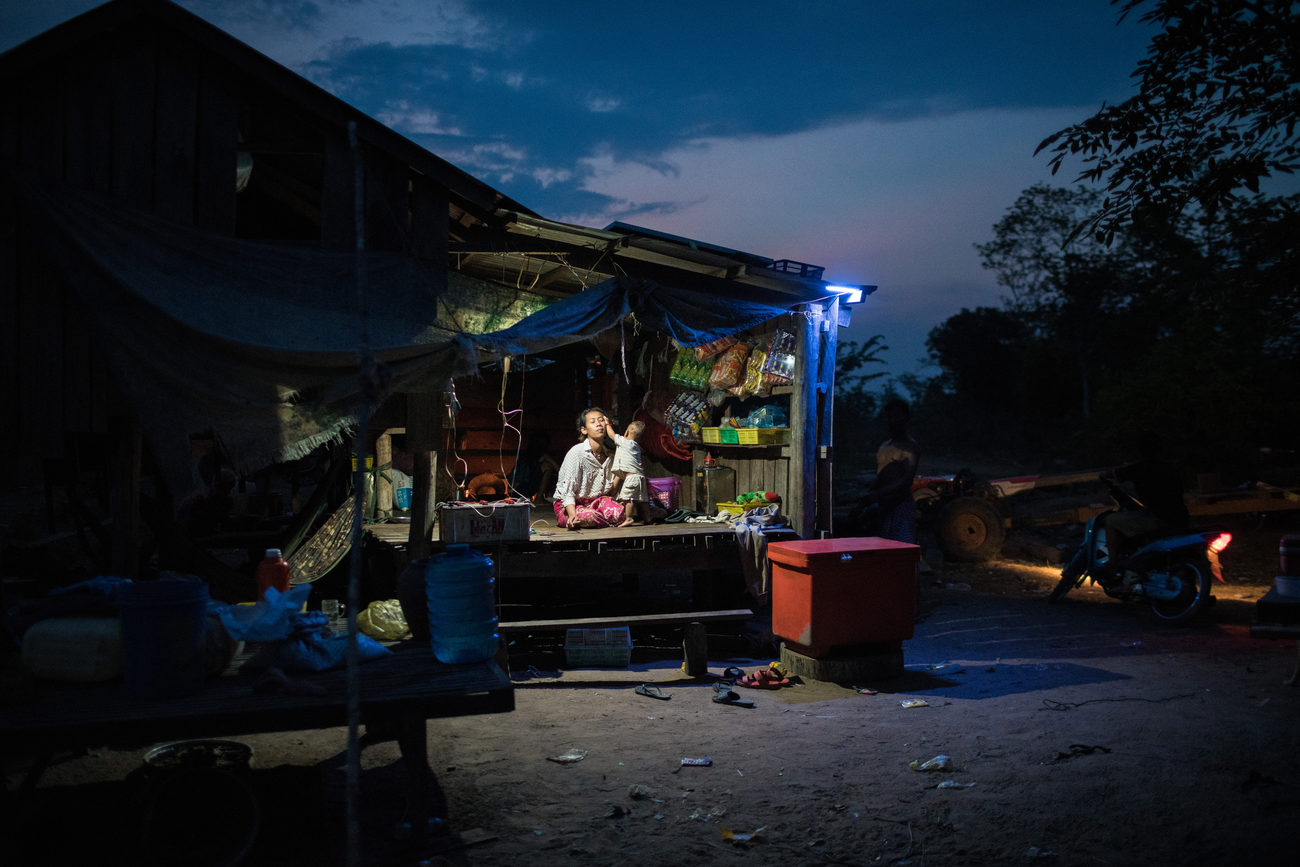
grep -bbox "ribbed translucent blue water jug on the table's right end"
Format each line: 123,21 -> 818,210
425,545 -> 501,663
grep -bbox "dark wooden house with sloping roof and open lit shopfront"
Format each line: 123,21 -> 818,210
0,0 -> 863,592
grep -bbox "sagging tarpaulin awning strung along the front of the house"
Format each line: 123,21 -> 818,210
12,171 -> 789,490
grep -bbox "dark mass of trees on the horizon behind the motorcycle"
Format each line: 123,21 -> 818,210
920,186 -> 1300,476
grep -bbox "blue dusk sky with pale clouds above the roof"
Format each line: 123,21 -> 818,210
0,0 -> 1152,376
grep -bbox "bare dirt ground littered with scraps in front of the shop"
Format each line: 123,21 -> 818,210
5,516 -> 1300,866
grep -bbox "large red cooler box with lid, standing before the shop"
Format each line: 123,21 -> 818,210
767,536 -> 920,656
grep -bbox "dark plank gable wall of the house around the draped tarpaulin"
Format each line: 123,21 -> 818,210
0,18 -> 457,484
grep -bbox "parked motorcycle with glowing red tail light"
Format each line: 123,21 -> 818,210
1048,480 -> 1232,624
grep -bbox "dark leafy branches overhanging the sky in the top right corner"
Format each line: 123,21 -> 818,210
1035,0 -> 1300,244
